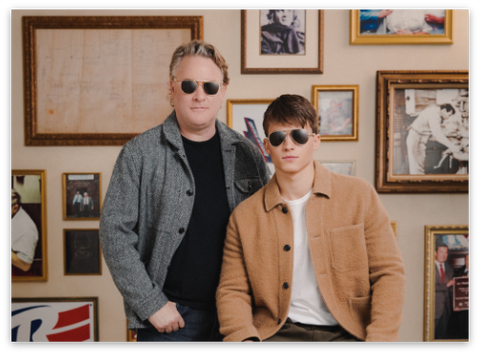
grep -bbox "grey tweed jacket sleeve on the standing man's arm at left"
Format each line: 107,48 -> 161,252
99,146 -> 168,321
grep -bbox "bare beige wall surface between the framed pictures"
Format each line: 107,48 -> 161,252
11,9 -> 470,341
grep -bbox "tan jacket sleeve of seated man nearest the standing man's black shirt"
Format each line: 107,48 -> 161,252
217,212 -> 260,342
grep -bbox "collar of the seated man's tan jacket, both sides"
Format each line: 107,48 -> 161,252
264,161 -> 332,212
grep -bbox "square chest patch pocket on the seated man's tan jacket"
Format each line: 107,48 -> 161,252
327,223 -> 368,271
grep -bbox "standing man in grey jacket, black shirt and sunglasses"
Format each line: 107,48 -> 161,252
100,41 -> 268,342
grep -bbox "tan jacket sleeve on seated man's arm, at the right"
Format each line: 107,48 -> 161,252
364,185 -> 405,341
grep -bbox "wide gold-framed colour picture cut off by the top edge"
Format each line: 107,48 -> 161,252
350,8 -> 453,45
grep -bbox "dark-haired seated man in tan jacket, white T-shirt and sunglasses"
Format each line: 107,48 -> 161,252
217,95 -> 405,341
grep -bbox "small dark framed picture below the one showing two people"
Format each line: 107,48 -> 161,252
63,229 -> 102,276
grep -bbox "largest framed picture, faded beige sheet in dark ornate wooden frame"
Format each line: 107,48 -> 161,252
22,16 -> 203,146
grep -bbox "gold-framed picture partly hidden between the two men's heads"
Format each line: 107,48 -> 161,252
227,99 -> 275,175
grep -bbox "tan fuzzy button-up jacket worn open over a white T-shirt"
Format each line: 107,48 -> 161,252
217,163 -> 405,341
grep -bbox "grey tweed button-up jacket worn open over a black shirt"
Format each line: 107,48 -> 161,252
100,111 -> 269,328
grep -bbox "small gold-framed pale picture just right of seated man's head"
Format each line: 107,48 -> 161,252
312,85 -> 359,142
